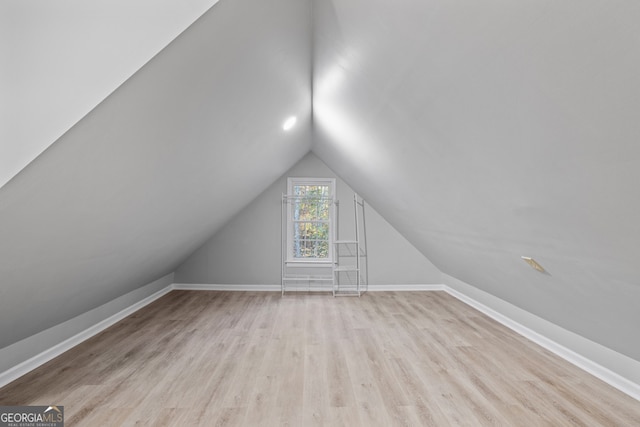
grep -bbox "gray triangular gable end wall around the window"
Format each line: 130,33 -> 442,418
175,153 -> 440,285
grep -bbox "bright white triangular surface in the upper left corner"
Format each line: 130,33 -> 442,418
0,0 -> 217,187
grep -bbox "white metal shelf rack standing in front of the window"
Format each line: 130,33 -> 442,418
281,194 -> 369,297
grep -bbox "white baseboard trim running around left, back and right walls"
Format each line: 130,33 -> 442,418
0,283 -> 640,401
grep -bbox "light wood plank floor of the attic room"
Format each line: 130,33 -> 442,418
0,291 -> 640,426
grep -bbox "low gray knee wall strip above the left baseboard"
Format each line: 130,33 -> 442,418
0,273 -> 174,384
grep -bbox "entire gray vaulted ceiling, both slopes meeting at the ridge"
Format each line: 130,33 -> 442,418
0,0 -> 640,372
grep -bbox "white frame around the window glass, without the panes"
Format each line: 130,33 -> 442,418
286,177 -> 336,267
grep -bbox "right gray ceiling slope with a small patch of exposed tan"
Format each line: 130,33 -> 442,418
313,0 -> 640,360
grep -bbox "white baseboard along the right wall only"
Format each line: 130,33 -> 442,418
444,285 -> 640,401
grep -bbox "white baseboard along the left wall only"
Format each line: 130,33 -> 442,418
0,285 -> 173,387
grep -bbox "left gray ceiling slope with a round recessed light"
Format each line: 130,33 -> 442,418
0,0 -> 311,347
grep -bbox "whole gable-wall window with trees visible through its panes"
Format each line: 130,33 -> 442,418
287,178 -> 335,262
